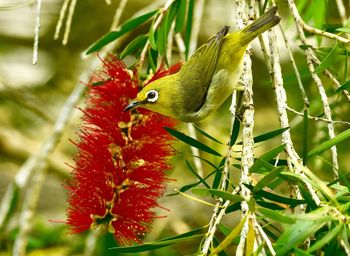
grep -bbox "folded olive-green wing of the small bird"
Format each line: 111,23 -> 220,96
179,26 -> 229,113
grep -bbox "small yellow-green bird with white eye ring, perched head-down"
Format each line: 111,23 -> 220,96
125,6 -> 280,122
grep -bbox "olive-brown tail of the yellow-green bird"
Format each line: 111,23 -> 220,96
240,6 -> 281,45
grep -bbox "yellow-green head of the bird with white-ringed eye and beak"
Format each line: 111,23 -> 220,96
124,76 -> 177,117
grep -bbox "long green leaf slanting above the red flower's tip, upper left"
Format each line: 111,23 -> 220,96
85,10 -> 158,55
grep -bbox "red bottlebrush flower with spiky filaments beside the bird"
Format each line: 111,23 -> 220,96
66,56 -> 175,244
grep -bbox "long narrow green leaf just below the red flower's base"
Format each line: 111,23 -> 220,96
110,227 -> 207,253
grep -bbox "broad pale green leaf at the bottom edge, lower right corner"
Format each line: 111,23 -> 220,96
275,219 -> 326,255
